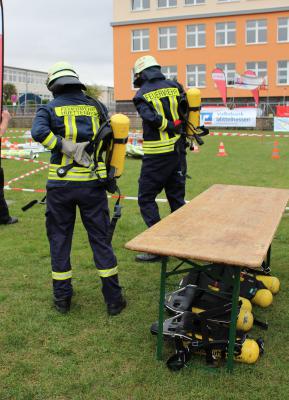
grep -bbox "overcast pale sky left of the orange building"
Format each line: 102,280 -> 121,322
3,0 -> 113,85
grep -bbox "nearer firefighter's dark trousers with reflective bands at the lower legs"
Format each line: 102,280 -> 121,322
46,186 -> 121,303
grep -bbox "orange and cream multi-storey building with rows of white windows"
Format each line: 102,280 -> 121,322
112,0 -> 289,111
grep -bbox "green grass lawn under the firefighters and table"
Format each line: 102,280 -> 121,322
0,133 -> 289,400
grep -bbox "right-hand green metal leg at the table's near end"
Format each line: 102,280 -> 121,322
227,267 -> 241,372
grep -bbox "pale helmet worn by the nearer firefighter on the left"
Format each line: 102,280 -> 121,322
46,61 -> 86,92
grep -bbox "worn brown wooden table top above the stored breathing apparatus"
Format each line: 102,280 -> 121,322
125,185 -> 289,269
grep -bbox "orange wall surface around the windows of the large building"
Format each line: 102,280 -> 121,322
113,12 -> 289,101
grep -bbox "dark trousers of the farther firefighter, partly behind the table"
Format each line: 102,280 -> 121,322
138,152 -> 186,227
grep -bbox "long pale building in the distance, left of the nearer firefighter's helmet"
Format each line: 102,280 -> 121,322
3,66 -> 52,100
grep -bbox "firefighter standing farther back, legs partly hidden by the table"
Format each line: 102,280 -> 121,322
133,56 -> 186,261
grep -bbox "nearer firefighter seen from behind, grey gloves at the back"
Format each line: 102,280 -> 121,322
32,62 -> 126,315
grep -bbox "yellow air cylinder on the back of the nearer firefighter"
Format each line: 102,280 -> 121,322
110,114 -> 129,178
